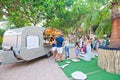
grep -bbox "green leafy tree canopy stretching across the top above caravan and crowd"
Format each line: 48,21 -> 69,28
0,0 -> 119,34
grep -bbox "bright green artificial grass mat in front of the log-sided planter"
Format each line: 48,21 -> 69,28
57,57 -> 120,80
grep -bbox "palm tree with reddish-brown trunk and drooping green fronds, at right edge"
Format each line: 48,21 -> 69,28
79,0 -> 120,48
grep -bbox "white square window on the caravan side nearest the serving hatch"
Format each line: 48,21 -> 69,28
26,36 -> 40,49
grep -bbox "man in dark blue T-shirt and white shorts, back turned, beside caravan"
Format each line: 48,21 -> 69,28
56,34 -> 65,62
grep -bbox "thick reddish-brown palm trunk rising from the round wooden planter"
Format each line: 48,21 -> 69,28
110,2 -> 120,48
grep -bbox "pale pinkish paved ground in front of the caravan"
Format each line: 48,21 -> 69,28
0,48 -> 74,80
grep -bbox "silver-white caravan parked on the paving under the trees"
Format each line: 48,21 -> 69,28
0,26 -> 51,64
